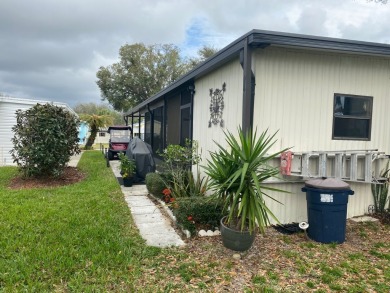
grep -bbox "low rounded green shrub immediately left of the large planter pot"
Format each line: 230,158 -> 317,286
173,197 -> 223,235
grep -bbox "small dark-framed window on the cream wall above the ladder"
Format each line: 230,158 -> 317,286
332,94 -> 372,140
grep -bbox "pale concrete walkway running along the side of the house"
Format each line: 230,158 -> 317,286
110,160 -> 185,247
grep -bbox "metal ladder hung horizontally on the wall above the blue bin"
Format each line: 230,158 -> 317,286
290,150 -> 389,183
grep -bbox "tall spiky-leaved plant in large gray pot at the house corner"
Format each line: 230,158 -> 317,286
204,127 -> 287,251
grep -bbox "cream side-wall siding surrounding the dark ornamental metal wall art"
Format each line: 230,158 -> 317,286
193,59 -> 243,156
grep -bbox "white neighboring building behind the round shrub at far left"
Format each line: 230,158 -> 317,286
0,97 -> 78,166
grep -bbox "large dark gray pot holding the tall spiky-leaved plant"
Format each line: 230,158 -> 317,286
220,217 -> 256,251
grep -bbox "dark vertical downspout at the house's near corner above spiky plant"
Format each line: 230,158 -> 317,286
240,38 -> 255,131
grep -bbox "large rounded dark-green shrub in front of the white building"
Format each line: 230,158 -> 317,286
10,104 -> 80,177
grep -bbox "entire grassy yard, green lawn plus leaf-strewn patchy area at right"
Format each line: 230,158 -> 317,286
0,151 -> 390,292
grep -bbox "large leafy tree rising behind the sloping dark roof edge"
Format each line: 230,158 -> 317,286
96,43 -> 187,111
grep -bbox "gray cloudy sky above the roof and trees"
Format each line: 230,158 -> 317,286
0,0 -> 390,106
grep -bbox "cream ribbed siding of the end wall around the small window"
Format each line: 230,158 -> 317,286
253,47 -> 390,223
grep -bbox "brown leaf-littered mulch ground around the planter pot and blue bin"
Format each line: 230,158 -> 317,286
138,221 -> 390,292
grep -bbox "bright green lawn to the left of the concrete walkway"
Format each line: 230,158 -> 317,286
0,152 -> 160,292
